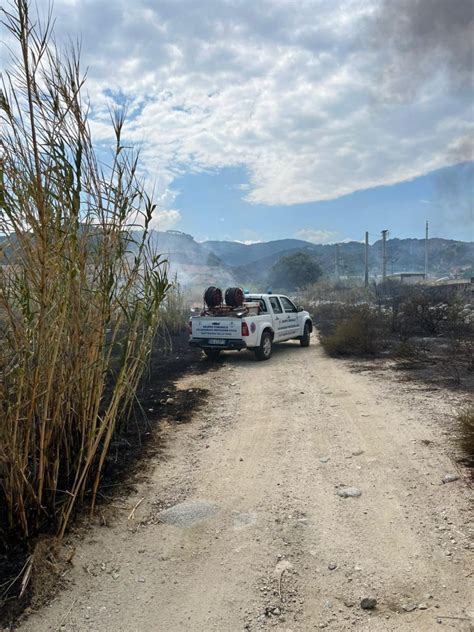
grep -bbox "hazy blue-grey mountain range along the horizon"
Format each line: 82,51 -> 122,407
0,231 -> 474,286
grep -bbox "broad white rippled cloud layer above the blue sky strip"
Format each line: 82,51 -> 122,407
29,0 -> 472,207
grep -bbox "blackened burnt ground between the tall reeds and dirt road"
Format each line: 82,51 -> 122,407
0,331 -> 216,629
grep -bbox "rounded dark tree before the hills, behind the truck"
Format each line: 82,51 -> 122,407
269,251 -> 322,290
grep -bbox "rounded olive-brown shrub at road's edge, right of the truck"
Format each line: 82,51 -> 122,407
321,305 -> 389,356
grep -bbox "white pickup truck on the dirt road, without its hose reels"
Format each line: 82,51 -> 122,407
189,294 -> 313,360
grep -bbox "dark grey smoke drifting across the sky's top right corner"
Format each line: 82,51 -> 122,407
367,0 -> 474,102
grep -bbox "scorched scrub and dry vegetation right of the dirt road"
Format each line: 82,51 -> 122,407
302,282 -> 474,467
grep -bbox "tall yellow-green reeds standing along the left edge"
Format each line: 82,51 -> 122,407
0,0 -> 169,544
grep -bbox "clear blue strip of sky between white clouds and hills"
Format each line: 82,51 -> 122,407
169,163 -> 474,243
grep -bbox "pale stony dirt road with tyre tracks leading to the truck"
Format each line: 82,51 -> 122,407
21,341 -> 474,632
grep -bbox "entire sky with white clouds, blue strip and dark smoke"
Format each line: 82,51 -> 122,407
4,0 -> 474,242
